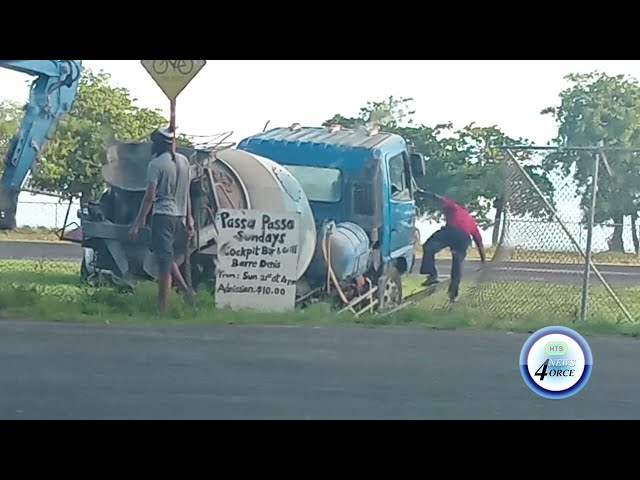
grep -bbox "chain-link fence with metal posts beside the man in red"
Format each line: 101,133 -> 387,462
456,149 -> 640,323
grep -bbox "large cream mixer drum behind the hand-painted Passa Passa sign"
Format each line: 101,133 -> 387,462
216,149 -> 316,280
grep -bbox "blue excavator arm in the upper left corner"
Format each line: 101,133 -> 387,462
0,60 -> 82,230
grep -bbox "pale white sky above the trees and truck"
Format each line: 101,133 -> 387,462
0,60 -> 640,251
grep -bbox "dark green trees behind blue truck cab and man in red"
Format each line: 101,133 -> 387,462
323,97 -> 553,245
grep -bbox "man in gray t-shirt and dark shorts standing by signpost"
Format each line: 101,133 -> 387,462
130,129 -> 195,313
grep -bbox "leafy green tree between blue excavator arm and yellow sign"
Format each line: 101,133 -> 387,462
30,70 -> 189,200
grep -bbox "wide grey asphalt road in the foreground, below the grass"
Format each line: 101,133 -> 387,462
0,321 -> 640,419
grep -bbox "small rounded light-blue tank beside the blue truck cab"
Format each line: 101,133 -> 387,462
309,222 -> 371,281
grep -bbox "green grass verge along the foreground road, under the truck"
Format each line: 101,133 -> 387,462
0,260 -> 640,336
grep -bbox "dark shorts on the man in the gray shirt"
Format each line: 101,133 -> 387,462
151,215 -> 187,275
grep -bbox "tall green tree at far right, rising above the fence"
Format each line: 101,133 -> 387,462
541,72 -> 640,252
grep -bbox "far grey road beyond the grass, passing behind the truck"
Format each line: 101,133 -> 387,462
0,241 -> 640,288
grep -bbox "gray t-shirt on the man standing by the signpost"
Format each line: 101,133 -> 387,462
147,152 -> 191,217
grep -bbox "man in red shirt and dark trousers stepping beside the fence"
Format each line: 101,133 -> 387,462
420,192 -> 486,301
